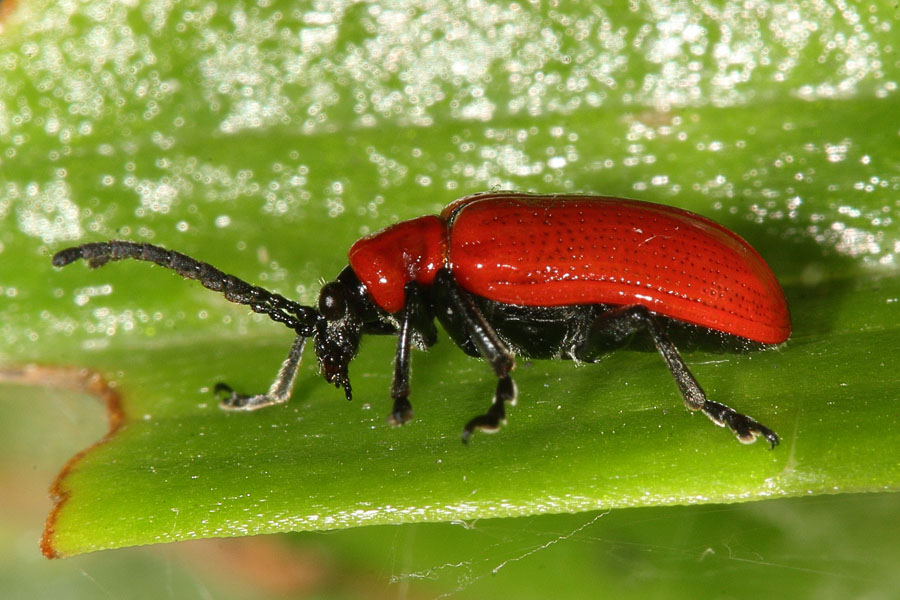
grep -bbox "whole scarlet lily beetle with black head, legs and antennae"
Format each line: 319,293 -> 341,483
53,192 -> 791,447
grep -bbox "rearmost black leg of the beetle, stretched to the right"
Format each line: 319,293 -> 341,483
574,305 -> 778,448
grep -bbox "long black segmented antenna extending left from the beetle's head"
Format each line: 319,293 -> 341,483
53,240 -> 320,337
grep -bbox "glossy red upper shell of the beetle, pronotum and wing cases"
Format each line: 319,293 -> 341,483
349,193 -> 791,344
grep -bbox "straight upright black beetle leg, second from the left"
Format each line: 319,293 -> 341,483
387,281 -> 437,425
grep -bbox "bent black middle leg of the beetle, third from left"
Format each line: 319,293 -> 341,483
434,268 -> 517,442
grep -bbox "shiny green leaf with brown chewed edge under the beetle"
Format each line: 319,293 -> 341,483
0,2 -> 900,555
